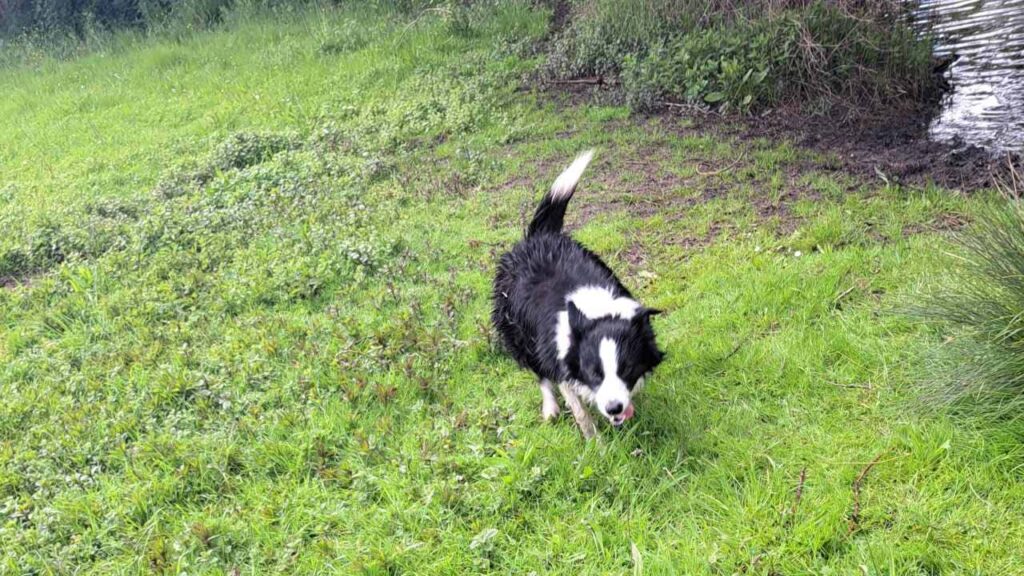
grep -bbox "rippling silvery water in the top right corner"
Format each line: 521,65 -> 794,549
915,0 -> 1024,154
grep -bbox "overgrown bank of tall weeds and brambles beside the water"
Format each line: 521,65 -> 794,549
549,0 -> 939,113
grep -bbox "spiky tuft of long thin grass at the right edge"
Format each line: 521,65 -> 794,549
911,169 -> 1024,411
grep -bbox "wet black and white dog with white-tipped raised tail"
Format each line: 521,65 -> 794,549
493,151 -> 664,438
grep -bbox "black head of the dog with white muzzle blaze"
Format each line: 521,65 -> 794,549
565,302 -> 665,426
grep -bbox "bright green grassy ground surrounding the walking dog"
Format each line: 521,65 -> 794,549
0,2 -> 1024,574
